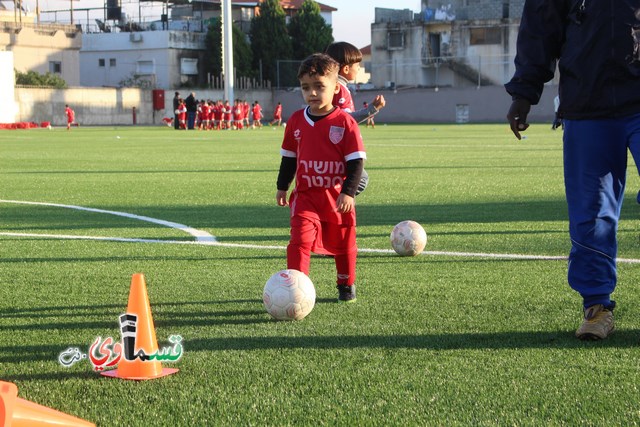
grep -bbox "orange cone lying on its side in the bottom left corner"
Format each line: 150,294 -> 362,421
0,381 -> 95,427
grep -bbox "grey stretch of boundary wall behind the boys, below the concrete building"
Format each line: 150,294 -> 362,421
276,85 -> 558,124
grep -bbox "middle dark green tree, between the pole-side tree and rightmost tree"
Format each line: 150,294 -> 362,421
251,0 -> 292,85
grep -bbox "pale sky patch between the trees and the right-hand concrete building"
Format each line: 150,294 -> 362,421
317,0 -> 420,48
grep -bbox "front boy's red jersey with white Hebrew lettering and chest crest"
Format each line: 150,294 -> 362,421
280,108 -> 367,225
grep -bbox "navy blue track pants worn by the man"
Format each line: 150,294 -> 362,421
564,114 -> 640,308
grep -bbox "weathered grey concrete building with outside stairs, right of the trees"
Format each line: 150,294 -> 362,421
371,0 -> 544,88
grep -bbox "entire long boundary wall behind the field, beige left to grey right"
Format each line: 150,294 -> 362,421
15,85 -> 558,126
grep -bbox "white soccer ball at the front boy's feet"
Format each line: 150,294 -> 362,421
262,270 -> 316,320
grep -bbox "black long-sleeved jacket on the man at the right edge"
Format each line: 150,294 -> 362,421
505,0 -> 640,120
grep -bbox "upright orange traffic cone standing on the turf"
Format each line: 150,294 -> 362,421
100,273 -> 178,381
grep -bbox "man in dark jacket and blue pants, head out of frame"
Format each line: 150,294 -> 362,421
505,0 -> 640,339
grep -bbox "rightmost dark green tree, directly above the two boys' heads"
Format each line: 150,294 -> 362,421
288,0 -> 333,59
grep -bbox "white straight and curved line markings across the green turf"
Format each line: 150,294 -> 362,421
0,199 -> 640,264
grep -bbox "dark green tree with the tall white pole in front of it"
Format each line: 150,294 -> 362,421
205,19 -> 257,78
